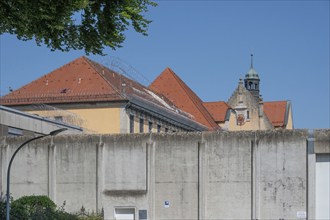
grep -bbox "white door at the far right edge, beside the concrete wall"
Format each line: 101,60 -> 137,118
315,154 -> 330,220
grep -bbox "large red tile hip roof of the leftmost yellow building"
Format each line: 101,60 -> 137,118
0,57 -> 183,115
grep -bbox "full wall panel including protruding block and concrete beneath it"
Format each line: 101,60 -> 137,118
98,134 -> 149,219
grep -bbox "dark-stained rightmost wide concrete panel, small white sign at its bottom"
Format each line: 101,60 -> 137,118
256,131 -> 307,219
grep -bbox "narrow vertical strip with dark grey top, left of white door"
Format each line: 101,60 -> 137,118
306,130 -> 316,219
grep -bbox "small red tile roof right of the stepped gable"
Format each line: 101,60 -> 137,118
264,101 -> 288,127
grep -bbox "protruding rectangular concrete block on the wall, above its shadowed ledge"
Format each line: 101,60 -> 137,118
103,135 -> 147,191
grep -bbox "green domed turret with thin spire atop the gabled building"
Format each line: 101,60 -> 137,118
244,54 -> 260,100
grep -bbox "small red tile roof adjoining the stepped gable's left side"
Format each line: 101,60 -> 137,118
203,101 -> 230,123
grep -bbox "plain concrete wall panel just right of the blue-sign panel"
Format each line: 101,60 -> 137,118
203,132 -> 252,219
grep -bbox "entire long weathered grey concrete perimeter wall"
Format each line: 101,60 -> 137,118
0,130 -> 330,220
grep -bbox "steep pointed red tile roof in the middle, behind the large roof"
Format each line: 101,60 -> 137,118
149,68 -> 219,130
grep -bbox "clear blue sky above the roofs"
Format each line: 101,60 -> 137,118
0,0 -> 330,128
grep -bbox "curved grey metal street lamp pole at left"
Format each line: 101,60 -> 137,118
6,128 -> 67,220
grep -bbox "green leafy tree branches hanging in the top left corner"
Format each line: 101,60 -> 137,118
0,0 -> 156,55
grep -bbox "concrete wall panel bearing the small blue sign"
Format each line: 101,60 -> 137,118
152,133 -> 201,219
